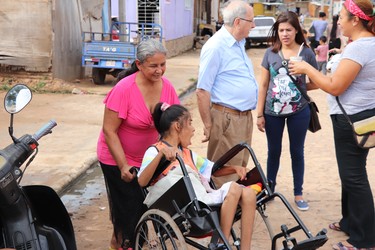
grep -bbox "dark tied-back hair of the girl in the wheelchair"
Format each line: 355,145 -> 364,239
152,102 -> 189,138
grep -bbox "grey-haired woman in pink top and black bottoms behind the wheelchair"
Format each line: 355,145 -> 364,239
97,39 -> 180,249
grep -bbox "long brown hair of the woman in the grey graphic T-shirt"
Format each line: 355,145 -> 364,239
269,11 -> 309,53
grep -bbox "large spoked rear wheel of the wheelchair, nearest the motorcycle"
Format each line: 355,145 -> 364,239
135,209 -> 187,250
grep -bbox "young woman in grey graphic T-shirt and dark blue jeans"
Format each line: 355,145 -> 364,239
257,11 -> 318,210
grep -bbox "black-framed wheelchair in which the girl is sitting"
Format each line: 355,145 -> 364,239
135,143 -> 328,250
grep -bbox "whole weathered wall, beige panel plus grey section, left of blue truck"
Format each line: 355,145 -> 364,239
0,0 -> 103,81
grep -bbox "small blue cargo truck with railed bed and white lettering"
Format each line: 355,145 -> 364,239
82,22 -> 163,85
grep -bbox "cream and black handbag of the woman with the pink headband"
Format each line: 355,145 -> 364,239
336,96 -> 375,149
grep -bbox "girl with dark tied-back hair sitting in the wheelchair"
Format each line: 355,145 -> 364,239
138,103 -> 256,249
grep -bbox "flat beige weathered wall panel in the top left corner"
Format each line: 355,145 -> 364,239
0,0 -> 53,72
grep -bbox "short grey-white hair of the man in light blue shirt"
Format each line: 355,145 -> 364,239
221,0 -> 249,27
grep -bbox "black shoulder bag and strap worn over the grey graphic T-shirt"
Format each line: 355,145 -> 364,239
279,50 -> 322,133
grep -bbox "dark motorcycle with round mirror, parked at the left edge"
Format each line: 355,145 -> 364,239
0,84 -> 77,250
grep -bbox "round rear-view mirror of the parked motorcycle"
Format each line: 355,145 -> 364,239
4,84 -> 32,114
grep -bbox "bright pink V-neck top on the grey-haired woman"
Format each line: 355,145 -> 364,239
97,73 -> 180,167
